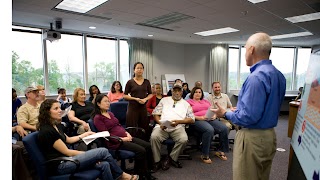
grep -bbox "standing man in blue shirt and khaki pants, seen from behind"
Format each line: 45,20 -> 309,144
212,33 -> 286,180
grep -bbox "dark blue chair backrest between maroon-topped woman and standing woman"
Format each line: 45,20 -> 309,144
110,101 -> 129,127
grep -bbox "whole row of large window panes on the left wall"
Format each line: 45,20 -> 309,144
12,26 -> 129,96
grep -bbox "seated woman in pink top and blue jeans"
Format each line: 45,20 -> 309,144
187,87 -> 229,164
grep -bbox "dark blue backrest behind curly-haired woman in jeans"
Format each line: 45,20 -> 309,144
22,131 -> 47,179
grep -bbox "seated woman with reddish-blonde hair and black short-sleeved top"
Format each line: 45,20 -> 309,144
68,88 -> 94,134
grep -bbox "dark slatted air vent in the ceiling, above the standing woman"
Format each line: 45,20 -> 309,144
137,12 -> 194,31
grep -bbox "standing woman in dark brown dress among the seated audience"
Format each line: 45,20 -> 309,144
123,62 -> 153,140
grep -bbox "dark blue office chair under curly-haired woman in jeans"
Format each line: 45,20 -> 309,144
22,131 -> 101,180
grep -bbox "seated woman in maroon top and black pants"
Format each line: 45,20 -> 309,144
93,94 -> 156,179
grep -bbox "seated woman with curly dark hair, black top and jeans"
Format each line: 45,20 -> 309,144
37,99 -> 139,180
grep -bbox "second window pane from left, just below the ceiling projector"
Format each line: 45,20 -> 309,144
46,34 -> 83,94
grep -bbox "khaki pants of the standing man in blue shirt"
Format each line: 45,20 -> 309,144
232,128 -> 277,180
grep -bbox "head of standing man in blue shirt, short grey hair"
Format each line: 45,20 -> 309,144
245,33 -> 272,66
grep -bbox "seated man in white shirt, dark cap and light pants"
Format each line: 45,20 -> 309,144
150,83 -> 195,171
